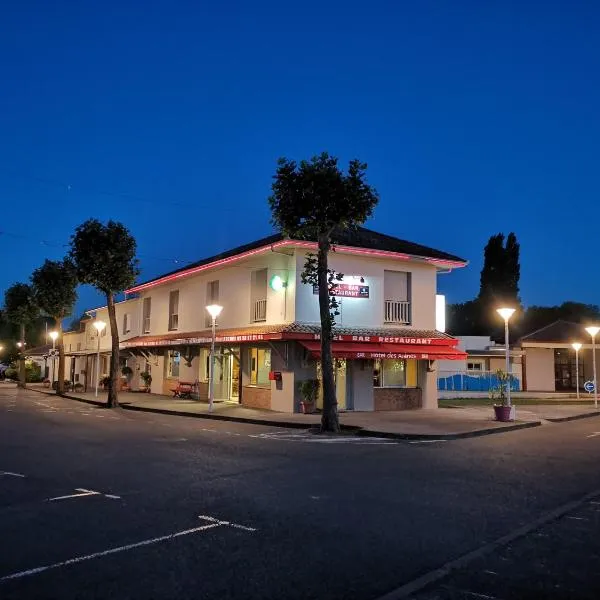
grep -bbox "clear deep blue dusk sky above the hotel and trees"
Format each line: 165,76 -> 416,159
0,0 -> 600,318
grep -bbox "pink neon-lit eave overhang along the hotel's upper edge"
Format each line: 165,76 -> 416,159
124,240 -> 468,296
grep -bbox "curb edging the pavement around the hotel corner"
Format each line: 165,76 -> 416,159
29,388 -> 544,441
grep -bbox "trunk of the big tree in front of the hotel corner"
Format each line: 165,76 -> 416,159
317,234 -> 340,433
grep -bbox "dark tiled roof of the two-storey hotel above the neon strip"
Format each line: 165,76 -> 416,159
134,227 -> 467,287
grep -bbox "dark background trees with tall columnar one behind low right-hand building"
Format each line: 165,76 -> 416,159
448,233 -> 600,341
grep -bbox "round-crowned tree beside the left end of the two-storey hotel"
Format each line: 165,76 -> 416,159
70,219 -> 139,407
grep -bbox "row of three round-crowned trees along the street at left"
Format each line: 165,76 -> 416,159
0,219 -> 138,407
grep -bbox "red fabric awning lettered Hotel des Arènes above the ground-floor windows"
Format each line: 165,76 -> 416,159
300,341 -> 467,360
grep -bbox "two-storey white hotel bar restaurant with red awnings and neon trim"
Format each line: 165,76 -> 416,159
30,228 -> 466,412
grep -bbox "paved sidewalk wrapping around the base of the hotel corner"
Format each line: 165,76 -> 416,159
24,386 -> 600,439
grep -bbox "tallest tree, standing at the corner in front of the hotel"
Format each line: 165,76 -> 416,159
269,152 -> 379,432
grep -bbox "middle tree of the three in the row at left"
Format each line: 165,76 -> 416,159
31,259 -> 77,394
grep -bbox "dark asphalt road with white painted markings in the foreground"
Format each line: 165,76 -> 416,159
0,386 -> 600,600
